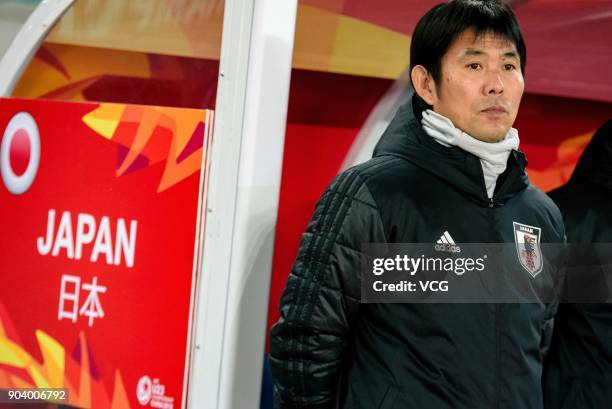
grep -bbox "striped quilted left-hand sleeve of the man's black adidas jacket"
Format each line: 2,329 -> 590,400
270,169 -> 384,409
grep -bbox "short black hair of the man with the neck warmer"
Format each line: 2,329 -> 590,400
410,0 -> 527,85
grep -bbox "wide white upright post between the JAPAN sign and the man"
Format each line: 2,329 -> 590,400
188,0 -> 297,409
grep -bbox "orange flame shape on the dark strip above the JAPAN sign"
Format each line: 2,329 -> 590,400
13,43 -> 151,100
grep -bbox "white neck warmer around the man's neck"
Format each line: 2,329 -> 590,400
421,109 -> 520,199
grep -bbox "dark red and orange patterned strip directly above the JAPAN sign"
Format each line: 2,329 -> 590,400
13,43 -> 219,109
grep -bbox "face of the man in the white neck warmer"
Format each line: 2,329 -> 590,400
431,29 -> 525,142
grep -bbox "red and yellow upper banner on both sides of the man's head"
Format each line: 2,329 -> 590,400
293,0 -> 612,102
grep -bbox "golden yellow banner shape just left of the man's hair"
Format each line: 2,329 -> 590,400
330,16 -> 411,79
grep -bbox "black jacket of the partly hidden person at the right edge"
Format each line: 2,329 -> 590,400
544,121 -> 612,409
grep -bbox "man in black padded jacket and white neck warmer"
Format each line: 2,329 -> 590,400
270,0 -> 564,409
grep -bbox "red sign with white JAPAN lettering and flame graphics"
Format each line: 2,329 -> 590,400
0,99 -> 212,409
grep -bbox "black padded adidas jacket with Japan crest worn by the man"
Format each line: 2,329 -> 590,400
270,96 -> 564,409
